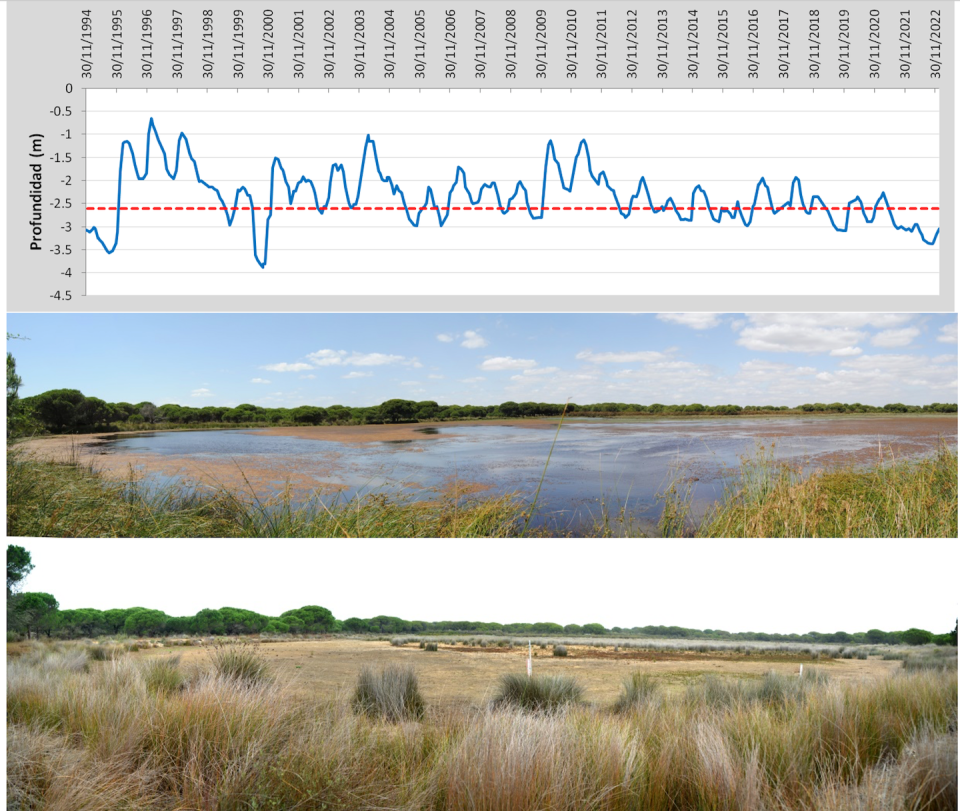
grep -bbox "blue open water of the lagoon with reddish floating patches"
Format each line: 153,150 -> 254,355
92,417 -> 957,531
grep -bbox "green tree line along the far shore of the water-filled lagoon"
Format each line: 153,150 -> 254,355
7,388 -> 957,434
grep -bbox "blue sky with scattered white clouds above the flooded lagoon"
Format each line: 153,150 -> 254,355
7,313 -> 957,407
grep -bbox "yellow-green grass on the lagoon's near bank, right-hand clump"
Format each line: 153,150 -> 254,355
659,443 -> 957,538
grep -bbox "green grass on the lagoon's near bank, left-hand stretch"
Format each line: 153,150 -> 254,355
7,448 -> 525,538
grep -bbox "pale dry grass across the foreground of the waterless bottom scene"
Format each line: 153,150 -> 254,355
7,646 -> 957,811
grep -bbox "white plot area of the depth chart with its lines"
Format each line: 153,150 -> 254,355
85,91 -> 940,294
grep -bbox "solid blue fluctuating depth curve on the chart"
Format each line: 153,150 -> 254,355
86,117 -> 940,268
